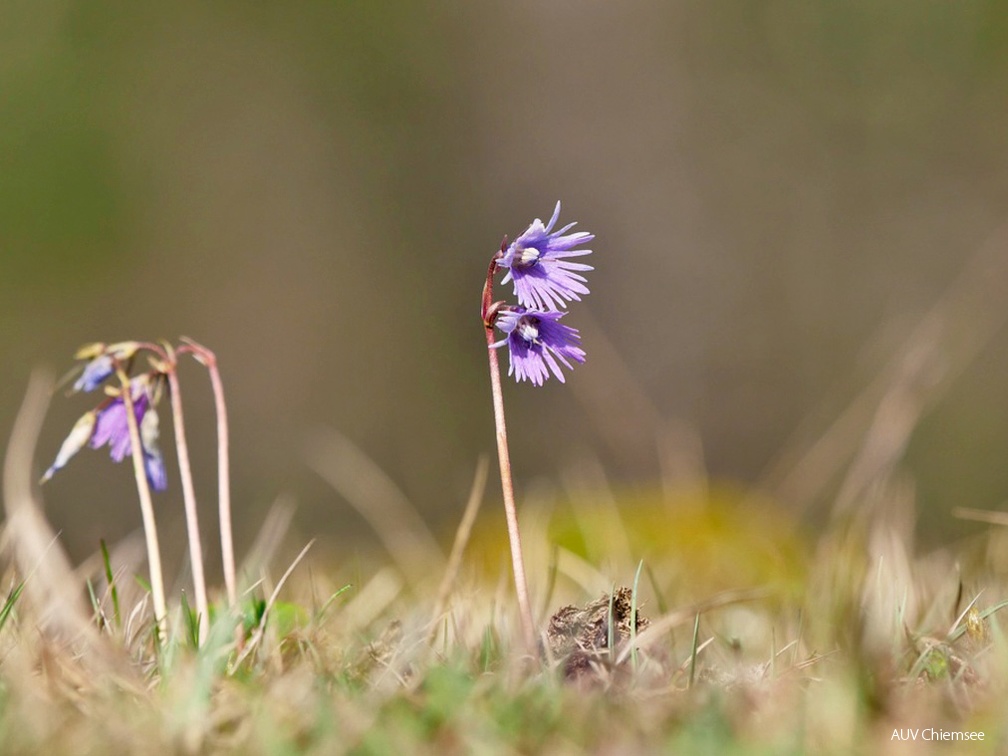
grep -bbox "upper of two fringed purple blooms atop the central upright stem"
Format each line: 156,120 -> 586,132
497,203 -> 595,309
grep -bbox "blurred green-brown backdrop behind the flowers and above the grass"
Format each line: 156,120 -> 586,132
0,0 -> 1008,572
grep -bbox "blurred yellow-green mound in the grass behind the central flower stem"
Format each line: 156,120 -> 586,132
469,484 -> 807,598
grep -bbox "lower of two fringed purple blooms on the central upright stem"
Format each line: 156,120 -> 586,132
493,305 -> 585,386
